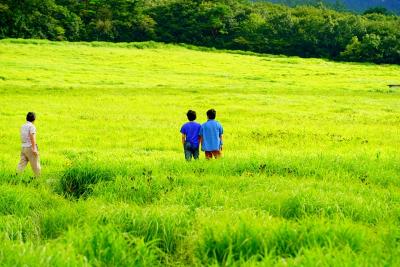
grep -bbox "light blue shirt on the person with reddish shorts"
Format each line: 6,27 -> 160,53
199,120 -> 224,151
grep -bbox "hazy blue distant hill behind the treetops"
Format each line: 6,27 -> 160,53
265,0 -> 400,14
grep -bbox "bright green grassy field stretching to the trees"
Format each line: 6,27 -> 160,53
0,40 -> 400,266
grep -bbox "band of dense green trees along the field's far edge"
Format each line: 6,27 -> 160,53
0,0 -> 400,64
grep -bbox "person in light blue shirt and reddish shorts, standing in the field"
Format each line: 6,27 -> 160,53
199,109 -> 224,159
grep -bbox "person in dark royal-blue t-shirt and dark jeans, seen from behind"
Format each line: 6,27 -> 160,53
181,110 -> 201,160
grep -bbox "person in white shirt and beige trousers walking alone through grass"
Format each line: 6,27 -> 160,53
17,112 -> 41,177
